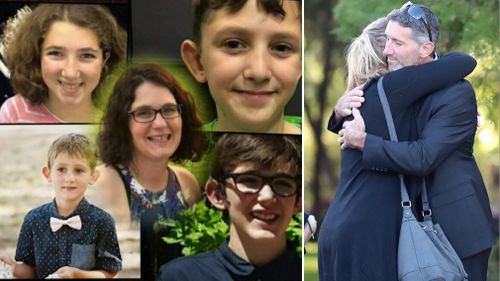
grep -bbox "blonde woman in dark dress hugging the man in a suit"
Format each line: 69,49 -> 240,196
318,7 -> 476,281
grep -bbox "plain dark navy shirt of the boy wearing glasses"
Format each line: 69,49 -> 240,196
157,238 -> 302,281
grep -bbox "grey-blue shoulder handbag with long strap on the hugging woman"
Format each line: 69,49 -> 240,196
377,77 -> 468,281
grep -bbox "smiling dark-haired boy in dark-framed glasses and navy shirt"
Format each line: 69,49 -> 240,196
158,134 -> 302,281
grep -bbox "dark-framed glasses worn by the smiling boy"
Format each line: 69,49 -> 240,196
224,173 -> 299,197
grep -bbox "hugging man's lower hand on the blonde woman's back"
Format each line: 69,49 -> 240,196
339,108 -> 366,151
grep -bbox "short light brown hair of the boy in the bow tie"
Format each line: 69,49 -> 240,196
47,133 -> 97,170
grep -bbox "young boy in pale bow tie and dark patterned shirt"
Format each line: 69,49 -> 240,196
0,134 -> 122,278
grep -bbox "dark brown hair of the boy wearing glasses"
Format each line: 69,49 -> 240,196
212,133 -> 302,193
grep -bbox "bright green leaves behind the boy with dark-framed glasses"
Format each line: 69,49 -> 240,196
159,199 -> 302,256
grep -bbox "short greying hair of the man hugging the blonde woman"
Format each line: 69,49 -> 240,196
387,4 -> 439,46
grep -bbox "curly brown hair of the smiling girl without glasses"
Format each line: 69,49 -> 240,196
5,4 -> 127,105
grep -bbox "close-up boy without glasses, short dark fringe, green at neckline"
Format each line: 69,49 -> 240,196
181,0 -> 302,134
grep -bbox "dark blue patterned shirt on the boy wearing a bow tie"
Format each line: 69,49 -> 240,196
16,198 -> 122,278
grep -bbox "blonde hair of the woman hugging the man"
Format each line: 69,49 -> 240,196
346,17 -> 387,91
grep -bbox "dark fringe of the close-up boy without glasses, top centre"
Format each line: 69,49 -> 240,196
193,0 -> 302,43
